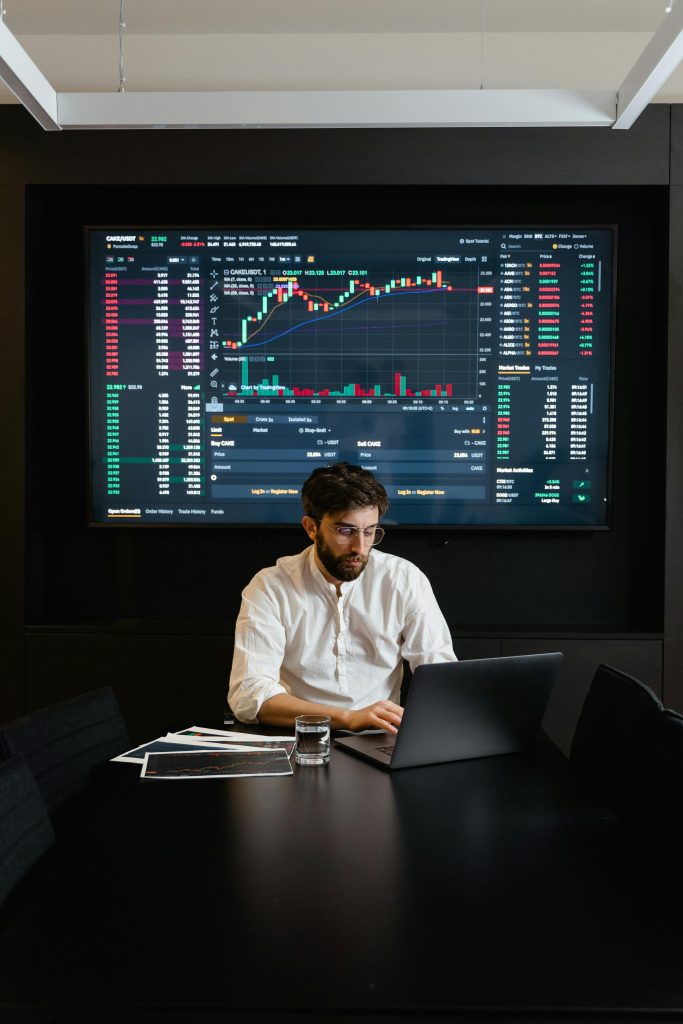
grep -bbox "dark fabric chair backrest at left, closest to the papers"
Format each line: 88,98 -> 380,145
0,686 -> 131,816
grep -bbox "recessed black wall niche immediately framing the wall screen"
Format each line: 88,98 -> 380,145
26,185 -> 668,633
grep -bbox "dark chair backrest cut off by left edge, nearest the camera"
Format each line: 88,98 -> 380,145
0,756 -> 54,904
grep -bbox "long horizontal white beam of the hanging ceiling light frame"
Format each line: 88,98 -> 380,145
58,88 -> 618,128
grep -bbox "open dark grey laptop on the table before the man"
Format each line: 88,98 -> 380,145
335,653 -> 562,771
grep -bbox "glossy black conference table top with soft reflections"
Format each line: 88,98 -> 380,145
0,742 -> 683,1022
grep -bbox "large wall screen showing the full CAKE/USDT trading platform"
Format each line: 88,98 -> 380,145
87,226 -> 614,529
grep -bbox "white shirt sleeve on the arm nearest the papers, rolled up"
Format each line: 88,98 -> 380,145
227,578 -> 288,724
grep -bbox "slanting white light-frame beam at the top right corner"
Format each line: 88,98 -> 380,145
613,0 -> 683,128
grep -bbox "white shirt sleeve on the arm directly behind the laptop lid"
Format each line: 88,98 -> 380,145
401,566 -> 458,672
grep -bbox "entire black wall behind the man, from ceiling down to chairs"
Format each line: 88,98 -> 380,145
0,106 -> 683,743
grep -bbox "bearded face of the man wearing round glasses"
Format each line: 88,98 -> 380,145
304,508 -> 378,583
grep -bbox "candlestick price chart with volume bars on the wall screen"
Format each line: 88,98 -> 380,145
222,268 -> 485,398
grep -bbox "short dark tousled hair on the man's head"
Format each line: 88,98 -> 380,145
301,462 -> 389,522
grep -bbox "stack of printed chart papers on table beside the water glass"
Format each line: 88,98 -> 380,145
112,725 -> 294,779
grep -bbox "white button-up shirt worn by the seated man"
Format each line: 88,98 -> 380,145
228,545 -> 457,722
